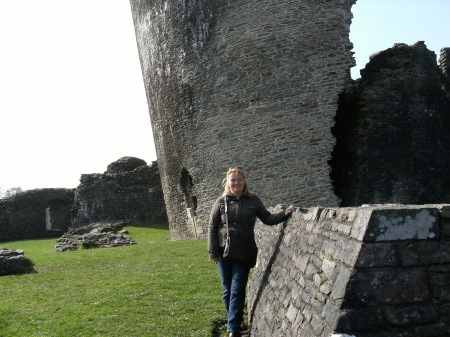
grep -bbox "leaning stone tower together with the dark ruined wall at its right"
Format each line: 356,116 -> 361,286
130,0 -> 450,239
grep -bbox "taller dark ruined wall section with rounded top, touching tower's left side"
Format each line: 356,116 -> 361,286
72,157 -> 167,226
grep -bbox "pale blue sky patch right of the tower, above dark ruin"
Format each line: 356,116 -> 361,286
350,0 -> 450,78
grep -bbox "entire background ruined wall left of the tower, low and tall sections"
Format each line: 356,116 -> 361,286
0,157 -> 167,242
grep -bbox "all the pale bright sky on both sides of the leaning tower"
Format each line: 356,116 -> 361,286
0,0 -> 450,190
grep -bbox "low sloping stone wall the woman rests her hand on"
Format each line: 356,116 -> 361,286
248,205 -> 450,337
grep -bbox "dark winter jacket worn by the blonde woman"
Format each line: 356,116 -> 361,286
208,193 -> 287,259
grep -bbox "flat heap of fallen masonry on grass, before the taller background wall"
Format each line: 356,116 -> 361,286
55,221 -> 136,252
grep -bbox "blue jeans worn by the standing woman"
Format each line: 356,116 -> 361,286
217,248 -> 250,332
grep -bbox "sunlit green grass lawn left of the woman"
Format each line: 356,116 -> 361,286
0,226 -> 225,337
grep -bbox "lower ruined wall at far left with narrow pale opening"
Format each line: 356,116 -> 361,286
0,188 -> 74,241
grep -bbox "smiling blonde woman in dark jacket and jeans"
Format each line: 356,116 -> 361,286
208,167 -> 295,337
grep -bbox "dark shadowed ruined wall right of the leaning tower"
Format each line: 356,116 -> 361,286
331,42 -> 450,206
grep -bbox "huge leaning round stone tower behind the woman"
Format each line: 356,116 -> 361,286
130,0 -> 356,239
